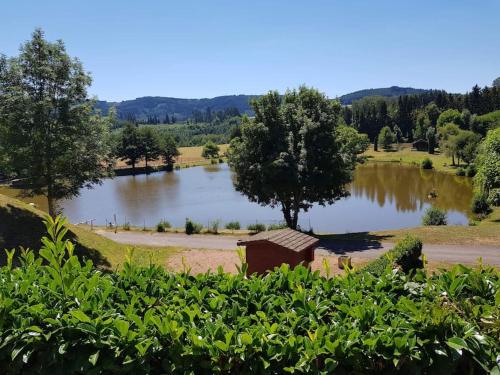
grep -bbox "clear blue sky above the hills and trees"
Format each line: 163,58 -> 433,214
0,0 -> 500,100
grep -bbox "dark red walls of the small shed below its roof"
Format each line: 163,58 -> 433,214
246,242 -> 314,275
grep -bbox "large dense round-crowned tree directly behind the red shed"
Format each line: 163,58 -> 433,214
229,87 -> 366,228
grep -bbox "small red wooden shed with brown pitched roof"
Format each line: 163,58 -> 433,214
238,228 -> 319,275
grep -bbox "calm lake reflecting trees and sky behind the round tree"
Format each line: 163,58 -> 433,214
0,163 -> 472,233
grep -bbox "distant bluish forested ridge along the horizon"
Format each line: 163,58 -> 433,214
96,86 -> 429,121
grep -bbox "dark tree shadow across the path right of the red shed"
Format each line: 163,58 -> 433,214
316,232 -> 394,254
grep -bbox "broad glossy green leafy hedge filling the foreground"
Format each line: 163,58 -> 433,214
0,220 -> 500,374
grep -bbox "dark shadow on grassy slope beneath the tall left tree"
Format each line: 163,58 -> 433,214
0,204 -> 110,268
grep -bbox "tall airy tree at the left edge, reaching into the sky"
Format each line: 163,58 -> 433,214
0,29 -> 109,216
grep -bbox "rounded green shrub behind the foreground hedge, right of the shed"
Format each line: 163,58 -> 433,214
363,235 -> 422,275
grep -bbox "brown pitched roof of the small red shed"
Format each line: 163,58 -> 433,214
238,228 -> 319,252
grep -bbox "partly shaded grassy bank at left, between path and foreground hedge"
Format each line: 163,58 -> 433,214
0,194 -> 182,269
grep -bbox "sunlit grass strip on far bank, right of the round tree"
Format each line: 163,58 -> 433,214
364,143 -> 463,173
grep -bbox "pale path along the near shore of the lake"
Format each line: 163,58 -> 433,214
97,230 -> 500,266
